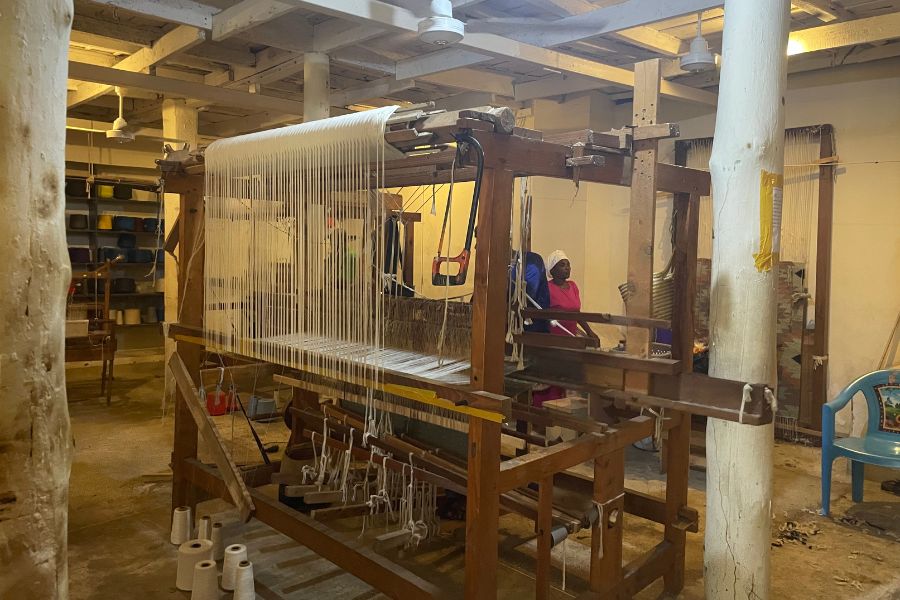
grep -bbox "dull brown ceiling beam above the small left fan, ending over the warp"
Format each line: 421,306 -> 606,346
69,61 -> 303,115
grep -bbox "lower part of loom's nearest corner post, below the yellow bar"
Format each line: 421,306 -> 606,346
465,417 -> 500,600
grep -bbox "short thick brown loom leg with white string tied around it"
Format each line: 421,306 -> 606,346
591,448 -> 625,596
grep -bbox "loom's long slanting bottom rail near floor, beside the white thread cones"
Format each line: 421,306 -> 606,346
187,460 -> 444,599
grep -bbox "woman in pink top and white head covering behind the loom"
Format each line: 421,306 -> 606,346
531,250 -> 600,406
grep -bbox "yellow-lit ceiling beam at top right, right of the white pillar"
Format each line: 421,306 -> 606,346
788,12 -> 900,55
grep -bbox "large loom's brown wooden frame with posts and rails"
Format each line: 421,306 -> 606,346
166,83 -> 771,599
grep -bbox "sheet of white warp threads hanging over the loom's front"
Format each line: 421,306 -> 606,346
204,106 -> 396,398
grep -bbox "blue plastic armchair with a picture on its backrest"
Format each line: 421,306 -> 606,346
822,370 -> 900,515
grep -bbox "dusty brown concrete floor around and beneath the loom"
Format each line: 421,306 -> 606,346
68,363 -> 900,600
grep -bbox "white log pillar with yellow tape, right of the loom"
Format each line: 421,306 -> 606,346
704,0 -> 790,600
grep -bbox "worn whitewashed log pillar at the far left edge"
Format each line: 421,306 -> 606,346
0,0 -> 73,600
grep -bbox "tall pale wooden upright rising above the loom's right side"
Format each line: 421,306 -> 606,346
625,59 -> 660,392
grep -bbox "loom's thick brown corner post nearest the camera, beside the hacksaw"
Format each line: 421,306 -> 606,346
465,168 -> 513,599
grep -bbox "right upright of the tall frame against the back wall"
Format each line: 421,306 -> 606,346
803,125 -> 835,431
